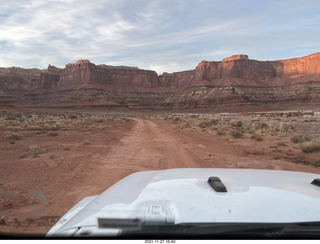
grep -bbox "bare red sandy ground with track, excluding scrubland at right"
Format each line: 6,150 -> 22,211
0,108 -> 320,236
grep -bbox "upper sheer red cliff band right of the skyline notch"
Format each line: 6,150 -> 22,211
160,53 -> 320,87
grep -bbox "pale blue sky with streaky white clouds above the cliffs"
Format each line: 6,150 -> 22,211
0,0 -> 320,74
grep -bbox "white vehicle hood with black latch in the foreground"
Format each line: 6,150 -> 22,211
47,168 -> 320,236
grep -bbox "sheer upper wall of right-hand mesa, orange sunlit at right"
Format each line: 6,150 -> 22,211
192,53 -> 320,86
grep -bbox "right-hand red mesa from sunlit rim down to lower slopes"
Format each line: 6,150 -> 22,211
165,53 -> 320,107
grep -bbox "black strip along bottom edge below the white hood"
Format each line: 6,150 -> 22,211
121,222 -> 320,238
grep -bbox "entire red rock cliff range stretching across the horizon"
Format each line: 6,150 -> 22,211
0,53 -> 320,109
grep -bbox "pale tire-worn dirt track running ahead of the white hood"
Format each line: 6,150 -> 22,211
96,118 -> 205,171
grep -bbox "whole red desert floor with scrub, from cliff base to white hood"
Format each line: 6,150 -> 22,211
0,107 -> 320,236
